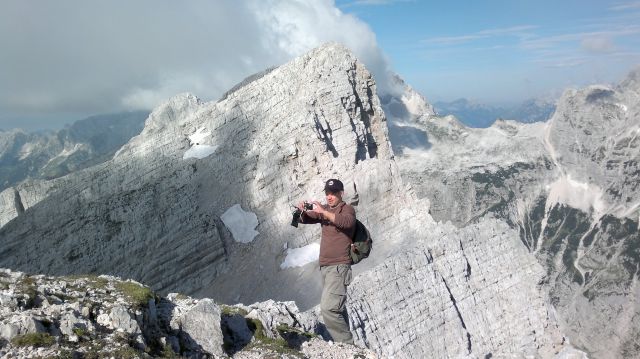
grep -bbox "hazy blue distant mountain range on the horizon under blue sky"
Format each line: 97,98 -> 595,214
433,98 -> 556,127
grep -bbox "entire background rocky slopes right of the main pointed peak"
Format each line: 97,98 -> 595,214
398,71 -> 640,357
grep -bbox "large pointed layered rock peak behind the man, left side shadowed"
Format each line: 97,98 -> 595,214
0,46 -> 409,307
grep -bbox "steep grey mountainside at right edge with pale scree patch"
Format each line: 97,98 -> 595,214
528,75 -> 640,357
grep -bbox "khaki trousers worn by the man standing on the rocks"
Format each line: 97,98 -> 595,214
320,264 -> 353,344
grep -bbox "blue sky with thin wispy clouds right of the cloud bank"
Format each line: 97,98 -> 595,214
336,0 -> 640,104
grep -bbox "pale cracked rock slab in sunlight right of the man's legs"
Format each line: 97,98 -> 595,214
349,221 -> 566,358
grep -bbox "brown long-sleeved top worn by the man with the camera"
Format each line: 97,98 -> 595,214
302,202 -> 356,266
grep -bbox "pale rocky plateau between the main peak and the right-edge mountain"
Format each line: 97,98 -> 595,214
397,117 -> 556,227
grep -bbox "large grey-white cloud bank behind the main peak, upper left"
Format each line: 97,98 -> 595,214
0,0 -> 388,129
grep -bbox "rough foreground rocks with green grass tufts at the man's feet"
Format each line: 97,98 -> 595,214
0,269 -> 377,359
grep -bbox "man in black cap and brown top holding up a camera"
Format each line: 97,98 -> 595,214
298,179 -> 356,344
